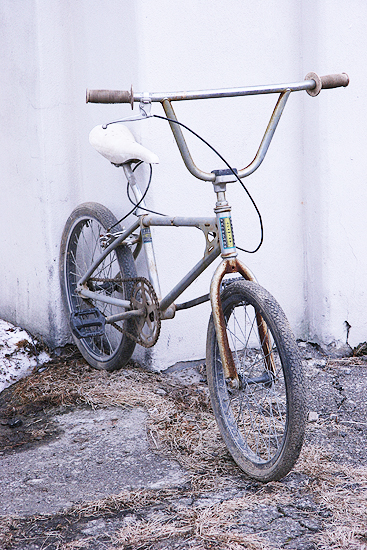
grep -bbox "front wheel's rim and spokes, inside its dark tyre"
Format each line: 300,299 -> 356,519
215,303 -> 288,465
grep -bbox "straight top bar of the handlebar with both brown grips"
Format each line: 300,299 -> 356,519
86,73 -> 349,107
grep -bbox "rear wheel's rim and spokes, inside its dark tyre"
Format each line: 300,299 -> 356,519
65,218 -> 125,362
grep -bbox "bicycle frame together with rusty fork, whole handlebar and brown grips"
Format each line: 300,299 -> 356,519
82,73 -> 349,387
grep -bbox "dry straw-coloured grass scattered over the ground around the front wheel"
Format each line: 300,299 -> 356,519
4,360 -> 367,550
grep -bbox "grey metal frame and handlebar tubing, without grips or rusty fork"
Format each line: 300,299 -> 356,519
77,79 -> 315,323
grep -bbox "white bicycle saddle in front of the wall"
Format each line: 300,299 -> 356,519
89,124 -> 159,164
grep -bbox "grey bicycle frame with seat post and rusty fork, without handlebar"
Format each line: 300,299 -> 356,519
76,157 -> 262,385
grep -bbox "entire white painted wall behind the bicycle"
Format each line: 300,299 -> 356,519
0,0 -> 367,368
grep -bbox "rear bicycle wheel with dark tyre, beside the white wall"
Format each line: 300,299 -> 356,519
60,203 -> 136,371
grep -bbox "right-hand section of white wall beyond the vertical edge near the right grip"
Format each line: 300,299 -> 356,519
303,0 -> 367,352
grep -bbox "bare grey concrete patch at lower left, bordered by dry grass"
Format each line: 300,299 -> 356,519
0,408 -> 185,516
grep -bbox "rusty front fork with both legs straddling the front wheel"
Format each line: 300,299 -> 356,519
210,258 -> 275,389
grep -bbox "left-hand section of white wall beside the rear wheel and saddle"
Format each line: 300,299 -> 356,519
0,0 -> 141,345
